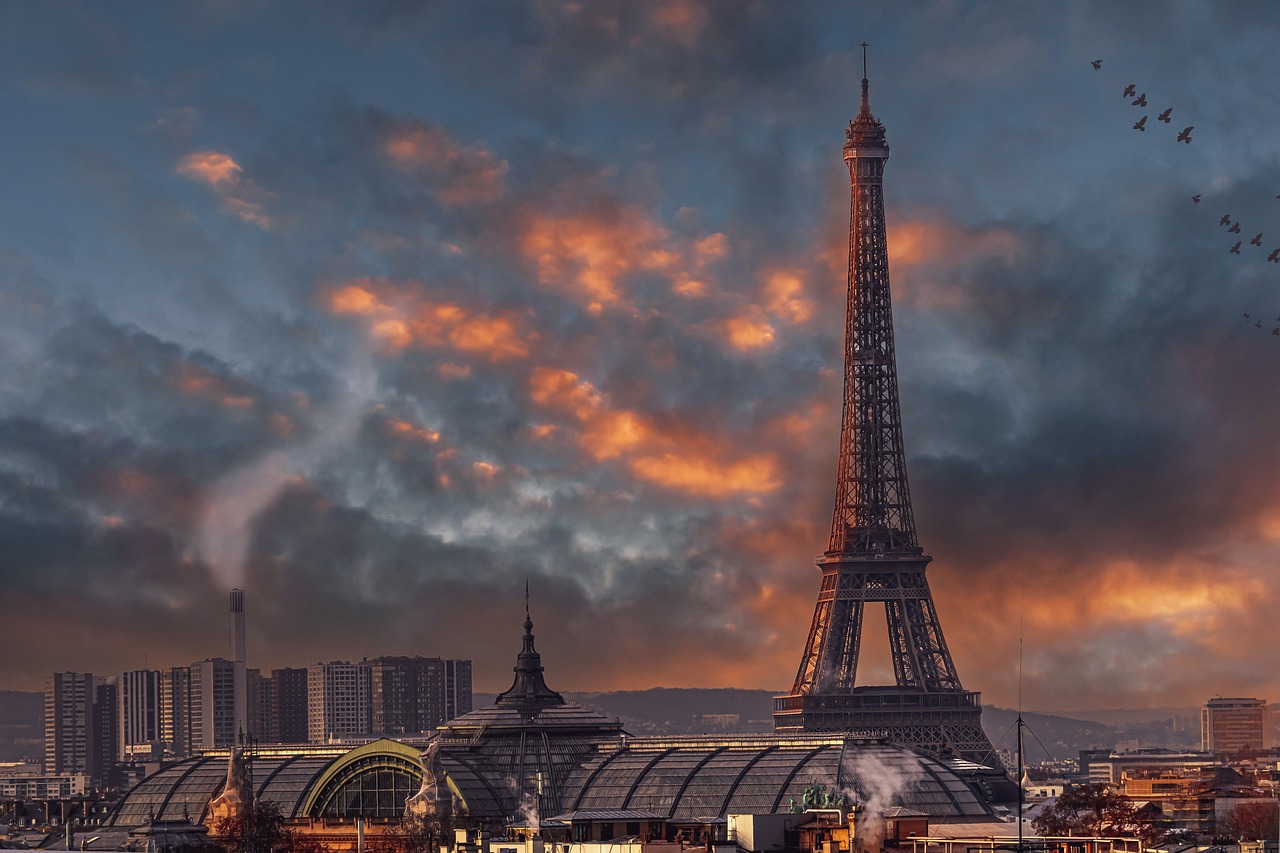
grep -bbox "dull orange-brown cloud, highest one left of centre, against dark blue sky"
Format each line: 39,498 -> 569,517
383,126 -> 507,205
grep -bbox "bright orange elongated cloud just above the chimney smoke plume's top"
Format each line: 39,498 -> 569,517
326,278 -> 538,358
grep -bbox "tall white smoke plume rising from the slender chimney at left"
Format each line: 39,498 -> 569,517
196,353 -> 378,588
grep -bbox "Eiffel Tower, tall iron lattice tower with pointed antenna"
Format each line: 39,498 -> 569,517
773,44 -> 1000,767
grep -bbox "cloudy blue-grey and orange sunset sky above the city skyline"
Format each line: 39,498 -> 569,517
0,0 -> 1280,711
